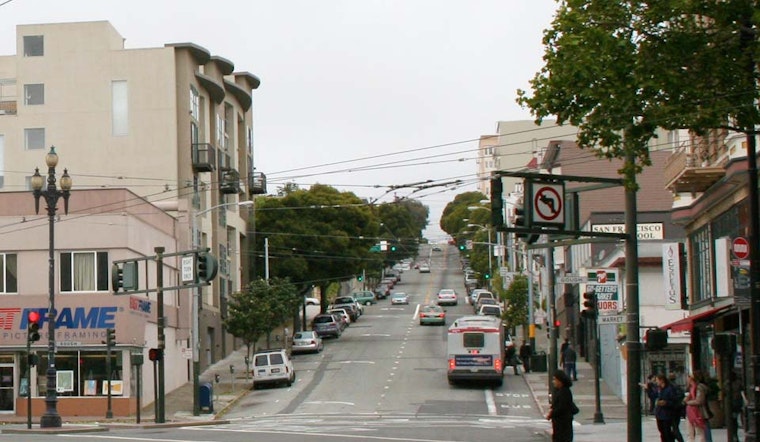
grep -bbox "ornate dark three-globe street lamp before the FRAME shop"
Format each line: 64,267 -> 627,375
32,146 -> 71,428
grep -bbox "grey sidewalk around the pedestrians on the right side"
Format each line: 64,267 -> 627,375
524,361 -> 743,442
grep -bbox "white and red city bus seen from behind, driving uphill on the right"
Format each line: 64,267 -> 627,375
448,316 -> 504,386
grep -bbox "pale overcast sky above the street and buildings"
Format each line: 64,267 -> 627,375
0,0 -> 556,241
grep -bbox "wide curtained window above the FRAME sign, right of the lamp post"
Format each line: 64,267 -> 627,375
60,252 -> 109,292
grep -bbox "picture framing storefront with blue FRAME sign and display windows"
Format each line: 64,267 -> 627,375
0,295 -> 153,418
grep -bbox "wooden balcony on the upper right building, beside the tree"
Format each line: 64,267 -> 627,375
664,149 -> 726,193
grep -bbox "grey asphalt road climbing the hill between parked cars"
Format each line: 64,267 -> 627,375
22,246 -> 549,442
